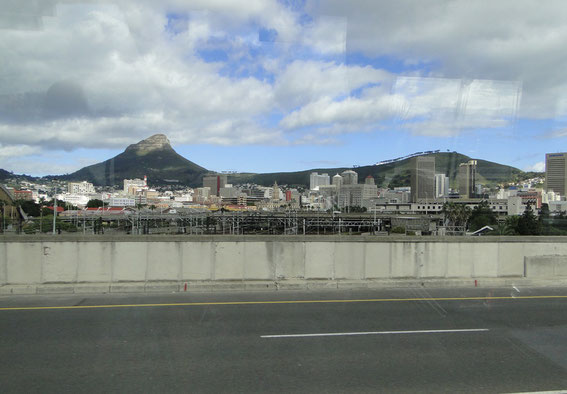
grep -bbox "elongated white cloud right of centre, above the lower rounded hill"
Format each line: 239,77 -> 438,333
280,74 -> 521,136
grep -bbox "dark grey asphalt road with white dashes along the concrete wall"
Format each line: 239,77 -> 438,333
0,288 -> 567,393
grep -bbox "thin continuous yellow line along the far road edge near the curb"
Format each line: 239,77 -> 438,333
0,295 -> 567,311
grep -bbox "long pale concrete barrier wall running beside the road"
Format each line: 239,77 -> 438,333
0,237 -> 567,285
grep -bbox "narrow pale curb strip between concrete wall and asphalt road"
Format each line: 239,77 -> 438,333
0,277 -> 567,296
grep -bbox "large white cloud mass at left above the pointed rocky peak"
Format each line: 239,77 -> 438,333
0,2 -> 277,154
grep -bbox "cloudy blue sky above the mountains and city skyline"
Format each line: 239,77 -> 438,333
0,0 -> 567,175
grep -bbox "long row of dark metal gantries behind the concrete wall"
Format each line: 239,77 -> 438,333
26,210 -> 441,235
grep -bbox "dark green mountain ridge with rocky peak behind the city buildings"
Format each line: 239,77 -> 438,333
0,134 -> 533,187
